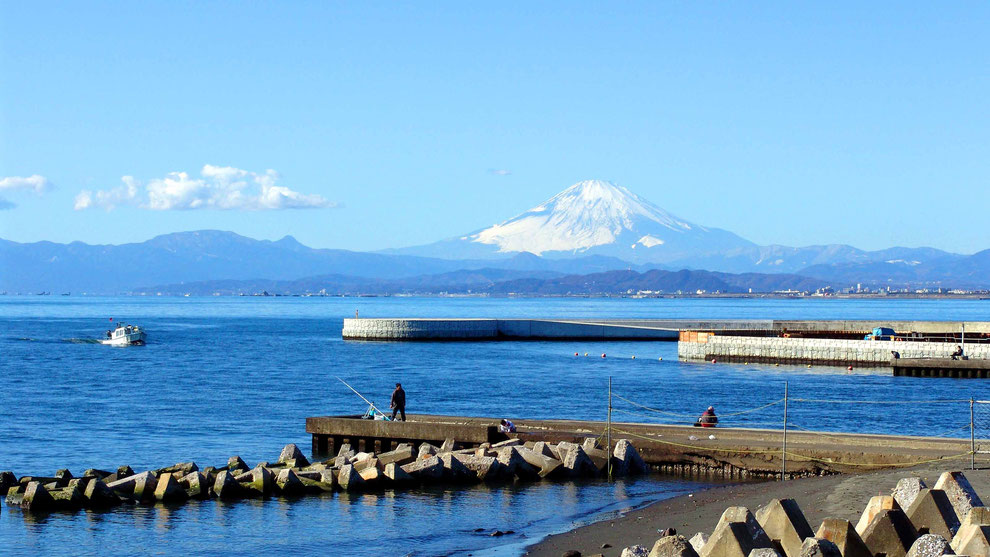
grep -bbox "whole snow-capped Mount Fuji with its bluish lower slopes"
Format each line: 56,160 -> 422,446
397,180 -> 754,264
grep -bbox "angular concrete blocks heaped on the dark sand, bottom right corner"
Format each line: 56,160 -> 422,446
602,471 -> 990,557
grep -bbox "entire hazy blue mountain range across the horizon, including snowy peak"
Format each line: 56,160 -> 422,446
0,180 -> 990,294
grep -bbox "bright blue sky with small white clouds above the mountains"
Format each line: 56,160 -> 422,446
0,1 -> 990,253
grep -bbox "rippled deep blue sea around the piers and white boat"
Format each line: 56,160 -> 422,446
0,296 -> 990,555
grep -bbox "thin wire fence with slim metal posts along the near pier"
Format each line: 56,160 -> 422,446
601,379 -> 990,478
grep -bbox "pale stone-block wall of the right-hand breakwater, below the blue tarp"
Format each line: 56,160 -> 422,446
677,332 -> 990,367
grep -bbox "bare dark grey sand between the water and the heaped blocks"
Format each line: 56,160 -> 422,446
526,462 -> 990,557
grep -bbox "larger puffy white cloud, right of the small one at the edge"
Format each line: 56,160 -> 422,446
75,164 -> 337,211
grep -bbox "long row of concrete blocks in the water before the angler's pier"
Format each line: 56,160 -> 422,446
0,439 -> 647,513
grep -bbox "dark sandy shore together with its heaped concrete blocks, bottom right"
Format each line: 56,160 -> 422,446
526,464 -> 990,557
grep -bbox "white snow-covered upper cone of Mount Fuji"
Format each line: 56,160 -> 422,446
468,180 -> 707,255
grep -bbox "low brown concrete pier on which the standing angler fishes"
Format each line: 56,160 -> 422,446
306,415 -> 990,478
